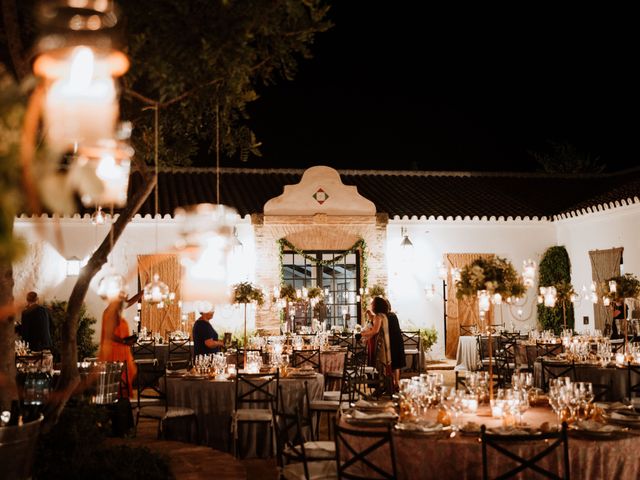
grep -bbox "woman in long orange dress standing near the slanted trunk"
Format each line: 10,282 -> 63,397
98,296 -> 137,398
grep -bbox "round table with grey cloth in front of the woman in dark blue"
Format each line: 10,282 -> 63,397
164,374 -> 324,457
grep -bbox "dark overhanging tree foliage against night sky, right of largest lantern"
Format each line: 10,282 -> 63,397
119,0 -> 331,165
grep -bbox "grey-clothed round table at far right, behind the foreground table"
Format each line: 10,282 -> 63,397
533,362 -> 640,402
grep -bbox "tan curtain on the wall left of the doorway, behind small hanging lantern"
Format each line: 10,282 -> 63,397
138,253 -> 181,338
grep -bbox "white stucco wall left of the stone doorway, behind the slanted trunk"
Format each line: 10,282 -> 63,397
14,216 -> 255,341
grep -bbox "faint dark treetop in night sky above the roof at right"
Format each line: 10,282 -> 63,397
529,142 -> 607,173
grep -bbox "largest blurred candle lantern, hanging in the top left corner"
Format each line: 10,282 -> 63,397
33,0 -> 129,152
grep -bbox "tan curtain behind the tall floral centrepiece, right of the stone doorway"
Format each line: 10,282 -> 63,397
444,253 -> 495,358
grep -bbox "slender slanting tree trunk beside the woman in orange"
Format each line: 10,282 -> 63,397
45,175 -> 156,428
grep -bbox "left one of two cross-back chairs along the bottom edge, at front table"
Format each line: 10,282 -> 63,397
335,422 -> 397,480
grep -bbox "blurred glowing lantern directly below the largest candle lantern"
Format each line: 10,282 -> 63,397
69,140 -> 133,207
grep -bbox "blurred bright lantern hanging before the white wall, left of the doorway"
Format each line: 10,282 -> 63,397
175,203 -> 238,304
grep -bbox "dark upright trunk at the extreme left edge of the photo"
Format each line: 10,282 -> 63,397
0,264 -> 18,411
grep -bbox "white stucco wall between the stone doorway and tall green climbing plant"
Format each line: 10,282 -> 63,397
387,218 -> 556,357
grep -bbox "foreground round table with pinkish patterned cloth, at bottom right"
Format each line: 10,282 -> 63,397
340,407 -> 640,480
